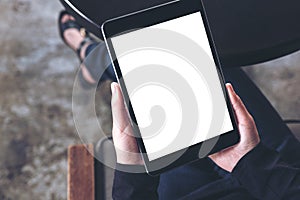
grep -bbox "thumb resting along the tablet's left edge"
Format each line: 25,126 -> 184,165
111,83 -> 129,131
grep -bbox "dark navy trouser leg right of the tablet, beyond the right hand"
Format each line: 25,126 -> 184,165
224,68 -> 300,164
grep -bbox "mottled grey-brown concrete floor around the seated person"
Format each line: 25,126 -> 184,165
0,0 -> 300,200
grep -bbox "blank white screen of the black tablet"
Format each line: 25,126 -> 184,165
111,12 -> 233,161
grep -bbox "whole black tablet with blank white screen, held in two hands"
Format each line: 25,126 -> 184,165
102,0 -> 240,175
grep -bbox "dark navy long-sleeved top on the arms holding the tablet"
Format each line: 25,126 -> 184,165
113,144 -> 300,200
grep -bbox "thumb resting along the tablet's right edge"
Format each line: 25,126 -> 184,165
226,83 -> 250,123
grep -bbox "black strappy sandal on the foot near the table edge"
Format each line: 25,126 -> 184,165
58,10 -> 94,62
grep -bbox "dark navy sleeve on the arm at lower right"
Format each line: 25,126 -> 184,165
232,145 -> 300,200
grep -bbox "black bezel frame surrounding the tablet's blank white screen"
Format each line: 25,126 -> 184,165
101,0 -> 240,175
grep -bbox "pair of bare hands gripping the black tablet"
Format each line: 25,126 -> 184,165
111,83 -> 260,172
